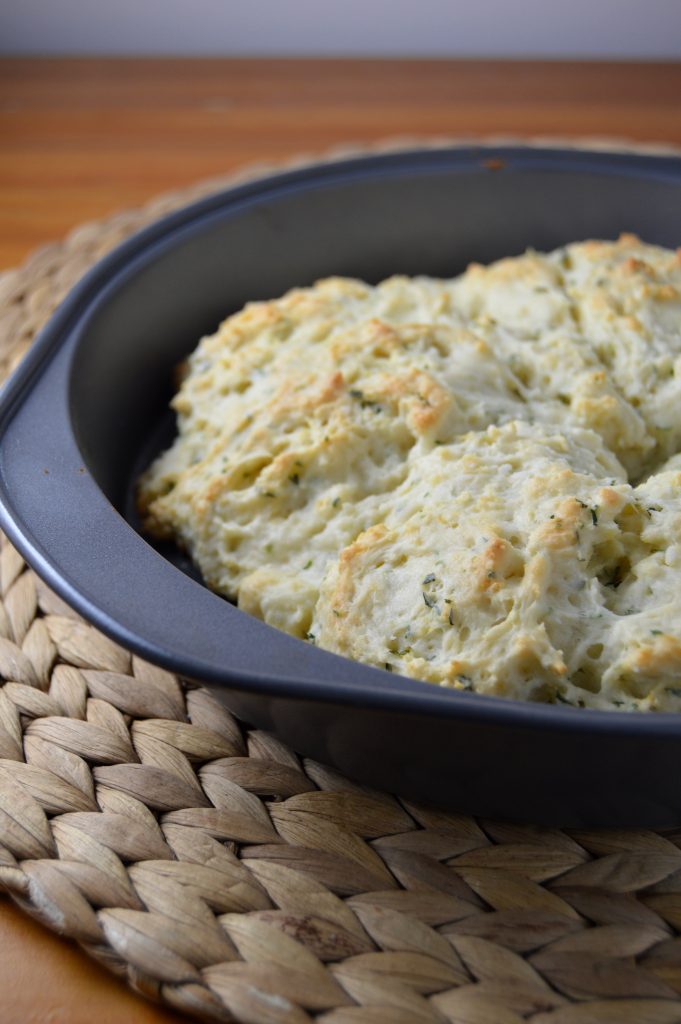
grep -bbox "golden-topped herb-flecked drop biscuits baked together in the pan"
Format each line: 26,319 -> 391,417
139,236 -> 681,711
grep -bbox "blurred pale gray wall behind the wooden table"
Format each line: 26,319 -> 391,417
0,0 -> 681,58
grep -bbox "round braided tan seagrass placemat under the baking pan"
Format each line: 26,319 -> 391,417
0,141 -> 681,1024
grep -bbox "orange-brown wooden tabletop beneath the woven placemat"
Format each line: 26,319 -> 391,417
0,59 -> 681,1024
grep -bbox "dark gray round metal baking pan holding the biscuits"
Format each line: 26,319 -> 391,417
0,147 -> 681,827
